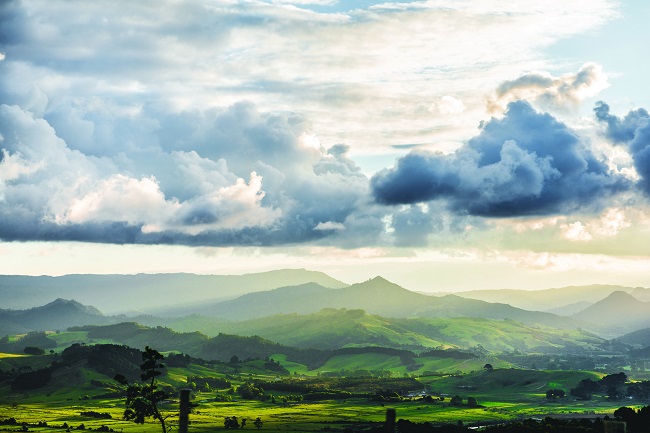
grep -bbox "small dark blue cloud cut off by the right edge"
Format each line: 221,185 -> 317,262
594,101 -> 650,195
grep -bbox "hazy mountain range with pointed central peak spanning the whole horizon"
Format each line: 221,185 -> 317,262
0,270 -> 650,344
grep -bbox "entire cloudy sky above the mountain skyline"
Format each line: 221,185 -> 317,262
0,0 -> 650,292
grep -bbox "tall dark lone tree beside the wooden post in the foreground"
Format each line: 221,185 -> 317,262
115,346 -> 170,433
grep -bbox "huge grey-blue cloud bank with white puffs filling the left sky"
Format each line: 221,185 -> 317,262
0,103 -> 372,245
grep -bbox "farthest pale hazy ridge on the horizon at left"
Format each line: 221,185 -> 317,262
0,269 -> 346,314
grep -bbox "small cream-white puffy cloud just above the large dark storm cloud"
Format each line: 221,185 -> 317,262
488,63 -> 609,112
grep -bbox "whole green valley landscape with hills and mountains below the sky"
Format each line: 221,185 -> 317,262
0,271 -> 650,432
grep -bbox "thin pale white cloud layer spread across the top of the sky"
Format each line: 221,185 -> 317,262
0,0 -> 616,151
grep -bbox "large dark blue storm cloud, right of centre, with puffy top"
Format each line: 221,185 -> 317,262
371,101 -> 627,217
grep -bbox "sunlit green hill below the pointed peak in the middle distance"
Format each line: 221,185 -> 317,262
213,309 -> 604,352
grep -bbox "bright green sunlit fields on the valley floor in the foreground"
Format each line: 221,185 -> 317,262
0,362 -> 636,433
